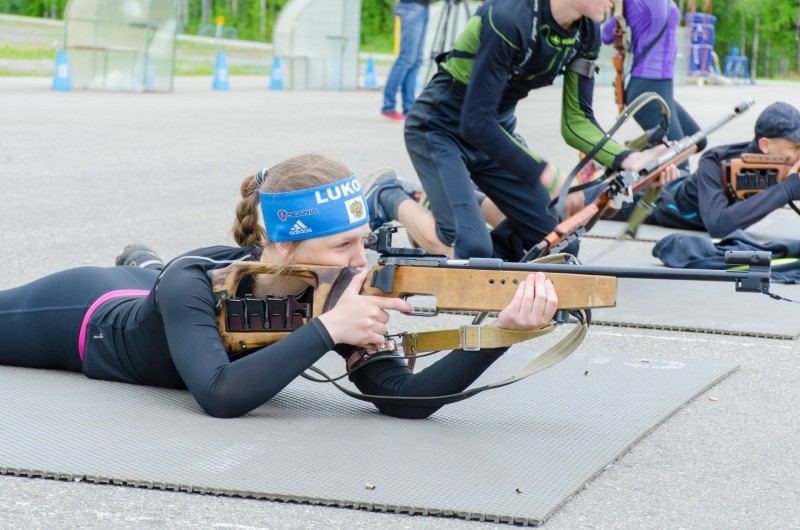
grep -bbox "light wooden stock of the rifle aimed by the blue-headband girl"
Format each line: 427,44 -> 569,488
211,257 -> 617,354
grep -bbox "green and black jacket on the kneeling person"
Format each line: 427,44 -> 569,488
441,0 -> 630,175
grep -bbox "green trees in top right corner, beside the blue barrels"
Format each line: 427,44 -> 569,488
713,0 -> 800,77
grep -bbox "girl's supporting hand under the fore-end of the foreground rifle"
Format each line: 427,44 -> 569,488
491,272 -> 558,331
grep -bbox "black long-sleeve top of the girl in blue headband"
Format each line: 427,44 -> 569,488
83,243 -> 507,418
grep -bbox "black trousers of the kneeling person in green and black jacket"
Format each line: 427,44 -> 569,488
405,72 -> 557,259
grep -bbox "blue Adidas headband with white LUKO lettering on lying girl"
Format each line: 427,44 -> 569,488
259,175 -> 369,243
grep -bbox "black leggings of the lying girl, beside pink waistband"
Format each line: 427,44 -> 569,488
0,267 -> 158,372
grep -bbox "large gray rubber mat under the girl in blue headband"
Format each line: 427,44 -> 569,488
0,345 -> 736,524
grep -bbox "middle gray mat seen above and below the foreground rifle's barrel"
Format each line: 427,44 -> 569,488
580,239 -> 800,339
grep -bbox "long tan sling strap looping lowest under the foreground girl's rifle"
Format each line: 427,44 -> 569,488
322,310 -> 589,406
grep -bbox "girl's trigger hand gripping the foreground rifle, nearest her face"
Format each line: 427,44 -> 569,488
319,269 -> 414,346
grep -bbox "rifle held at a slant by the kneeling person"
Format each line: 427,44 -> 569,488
521,99 -> 754,262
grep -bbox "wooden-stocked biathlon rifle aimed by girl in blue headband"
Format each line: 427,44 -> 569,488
211,225 -> 771,355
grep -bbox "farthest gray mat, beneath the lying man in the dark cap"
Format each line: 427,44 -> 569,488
583,207 -> 800,241
